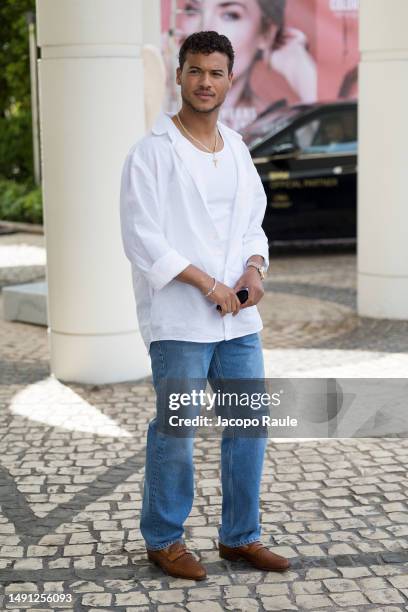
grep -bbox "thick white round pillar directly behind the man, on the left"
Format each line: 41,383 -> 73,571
37,0 -> 160,383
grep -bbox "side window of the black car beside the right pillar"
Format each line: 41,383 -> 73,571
294,109 -> 357,153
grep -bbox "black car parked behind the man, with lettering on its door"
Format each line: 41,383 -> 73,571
243,101 -> 357,245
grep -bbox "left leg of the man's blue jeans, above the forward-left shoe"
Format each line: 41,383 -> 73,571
140,340 -> 215,550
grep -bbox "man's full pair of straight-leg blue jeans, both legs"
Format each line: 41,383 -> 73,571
140,333 -> 267,550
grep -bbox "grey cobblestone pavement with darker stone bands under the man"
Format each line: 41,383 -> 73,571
0,234 -> 408,612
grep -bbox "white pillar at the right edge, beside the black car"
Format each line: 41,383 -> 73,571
357,0 -> 408,319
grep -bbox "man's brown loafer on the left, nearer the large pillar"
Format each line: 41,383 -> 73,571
146,542 -> 207,580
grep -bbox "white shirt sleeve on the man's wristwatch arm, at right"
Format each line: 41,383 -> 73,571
243,149 -> 269,268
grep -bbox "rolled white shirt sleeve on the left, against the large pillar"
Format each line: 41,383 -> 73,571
120,152 -> 190,290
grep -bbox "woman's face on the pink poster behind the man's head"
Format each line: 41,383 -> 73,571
177,0 -> 278,78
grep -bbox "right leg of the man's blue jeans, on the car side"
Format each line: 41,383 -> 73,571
210,333 -> 267,547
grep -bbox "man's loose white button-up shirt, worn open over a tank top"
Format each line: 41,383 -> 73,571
120,112 -> 269,351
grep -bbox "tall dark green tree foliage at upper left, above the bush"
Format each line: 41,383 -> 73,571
0,0 -> 35,182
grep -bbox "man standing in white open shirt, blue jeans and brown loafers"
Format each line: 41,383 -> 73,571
120,31 -> 289,580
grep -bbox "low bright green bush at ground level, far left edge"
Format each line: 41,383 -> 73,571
0,179 -> 43,224
